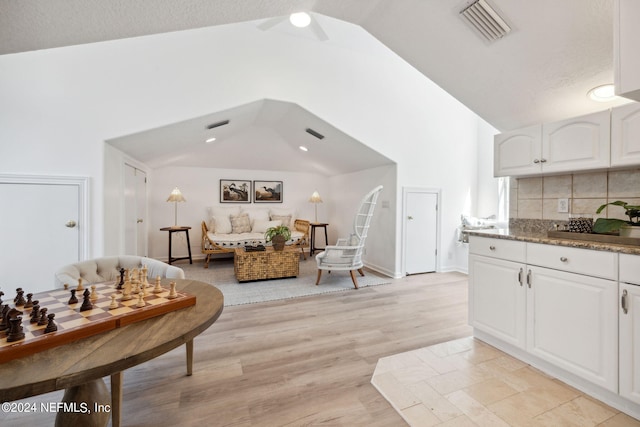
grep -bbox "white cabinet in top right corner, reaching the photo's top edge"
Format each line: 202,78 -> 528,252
613,0 -> 640,101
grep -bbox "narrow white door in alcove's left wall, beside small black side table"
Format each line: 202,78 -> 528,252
124,165 -> 147,256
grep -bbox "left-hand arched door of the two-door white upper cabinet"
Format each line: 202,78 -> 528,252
493,125 -> 542,176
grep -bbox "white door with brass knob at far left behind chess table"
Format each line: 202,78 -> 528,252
0,177 -> 87,297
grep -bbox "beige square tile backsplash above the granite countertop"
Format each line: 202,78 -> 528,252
509,168 -> 640,221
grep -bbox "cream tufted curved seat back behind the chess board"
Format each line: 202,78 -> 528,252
55,255 -> 184,288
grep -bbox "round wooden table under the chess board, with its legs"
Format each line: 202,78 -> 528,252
0,279 -> 224,427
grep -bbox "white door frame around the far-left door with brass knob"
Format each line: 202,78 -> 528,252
0,174 -> 90,261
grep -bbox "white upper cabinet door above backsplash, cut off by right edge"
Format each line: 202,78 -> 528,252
611,104 -> 640,166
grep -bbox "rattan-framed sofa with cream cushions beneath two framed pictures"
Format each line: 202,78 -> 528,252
201,206 -> 310,268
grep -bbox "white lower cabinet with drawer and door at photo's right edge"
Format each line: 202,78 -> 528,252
618,254 -> 640,404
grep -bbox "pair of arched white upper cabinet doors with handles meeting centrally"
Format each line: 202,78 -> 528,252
494,111 -> 611,176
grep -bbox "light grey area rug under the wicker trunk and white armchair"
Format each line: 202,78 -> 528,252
176,258 -> 391,306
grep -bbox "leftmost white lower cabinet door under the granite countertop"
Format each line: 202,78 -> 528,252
469,255 -> 527,349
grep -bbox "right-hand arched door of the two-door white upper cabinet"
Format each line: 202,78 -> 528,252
541,111 -> 611,173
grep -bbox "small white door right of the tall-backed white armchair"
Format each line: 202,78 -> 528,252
404,191 -> 438,274
